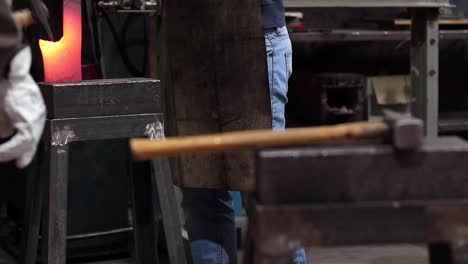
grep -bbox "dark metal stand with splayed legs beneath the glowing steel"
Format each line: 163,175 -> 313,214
22,80 -> 186,264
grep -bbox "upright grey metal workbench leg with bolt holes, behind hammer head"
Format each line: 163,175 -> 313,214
411,8 -> 439,138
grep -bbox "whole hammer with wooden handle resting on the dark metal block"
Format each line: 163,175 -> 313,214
130,110 -> 424,160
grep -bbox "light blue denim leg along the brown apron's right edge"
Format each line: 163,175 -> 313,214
265,27 -> 307,264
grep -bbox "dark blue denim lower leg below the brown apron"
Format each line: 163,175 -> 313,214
182,188 -> 237,264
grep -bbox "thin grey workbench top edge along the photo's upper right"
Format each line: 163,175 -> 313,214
284,0 -> 451,8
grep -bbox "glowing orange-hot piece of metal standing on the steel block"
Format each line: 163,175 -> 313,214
39,0 -> 81,82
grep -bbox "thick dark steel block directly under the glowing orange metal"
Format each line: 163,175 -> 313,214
40,78 -> 162,119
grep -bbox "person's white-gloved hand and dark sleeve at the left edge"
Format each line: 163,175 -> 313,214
0,2 -> 46,168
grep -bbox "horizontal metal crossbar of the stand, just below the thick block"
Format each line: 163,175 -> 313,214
44,113 -> 164,141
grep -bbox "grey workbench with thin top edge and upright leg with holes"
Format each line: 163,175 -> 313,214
285,0 -> 451,137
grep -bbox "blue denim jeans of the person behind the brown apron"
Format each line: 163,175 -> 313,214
182,27 -> 306,264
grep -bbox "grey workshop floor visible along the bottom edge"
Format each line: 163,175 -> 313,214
0,245 -> 428,264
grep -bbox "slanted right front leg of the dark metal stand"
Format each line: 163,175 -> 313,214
152,157 -> 187,264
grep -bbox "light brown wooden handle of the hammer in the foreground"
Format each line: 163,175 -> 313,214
130,122 -> 390,160
